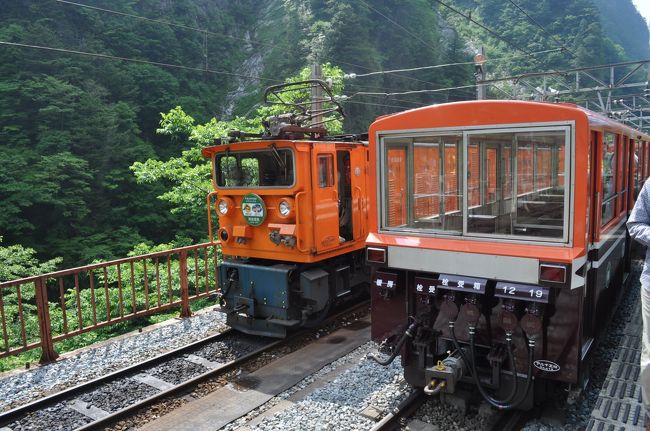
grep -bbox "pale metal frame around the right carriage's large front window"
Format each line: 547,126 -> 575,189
376,121 -> 576,247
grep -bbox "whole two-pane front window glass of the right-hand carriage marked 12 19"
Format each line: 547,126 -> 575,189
382,126 -> 569,242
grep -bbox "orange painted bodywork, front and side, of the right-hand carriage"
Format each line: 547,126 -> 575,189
367,101 -> 650,263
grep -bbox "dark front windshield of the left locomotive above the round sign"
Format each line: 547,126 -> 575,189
214,145 -> 294,188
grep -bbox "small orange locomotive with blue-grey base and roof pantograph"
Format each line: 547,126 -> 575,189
203,80 -> 368,337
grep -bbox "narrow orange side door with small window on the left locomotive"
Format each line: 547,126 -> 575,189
312,143 -> 340,253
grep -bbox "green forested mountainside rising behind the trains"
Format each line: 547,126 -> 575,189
0,0 -> 650,281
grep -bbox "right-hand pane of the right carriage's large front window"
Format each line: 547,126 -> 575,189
467,130 -> 566,239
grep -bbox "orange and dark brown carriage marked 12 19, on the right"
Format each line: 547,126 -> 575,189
367,101 -> 650,409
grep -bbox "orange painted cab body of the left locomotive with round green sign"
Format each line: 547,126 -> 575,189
203,140 -> 368,263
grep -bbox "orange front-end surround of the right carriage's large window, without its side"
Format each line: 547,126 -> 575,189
367,101 -> 588,262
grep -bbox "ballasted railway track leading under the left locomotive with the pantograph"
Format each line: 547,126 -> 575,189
0,301 -> 369,431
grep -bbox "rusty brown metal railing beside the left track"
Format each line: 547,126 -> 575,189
0,242 -> 219,363
